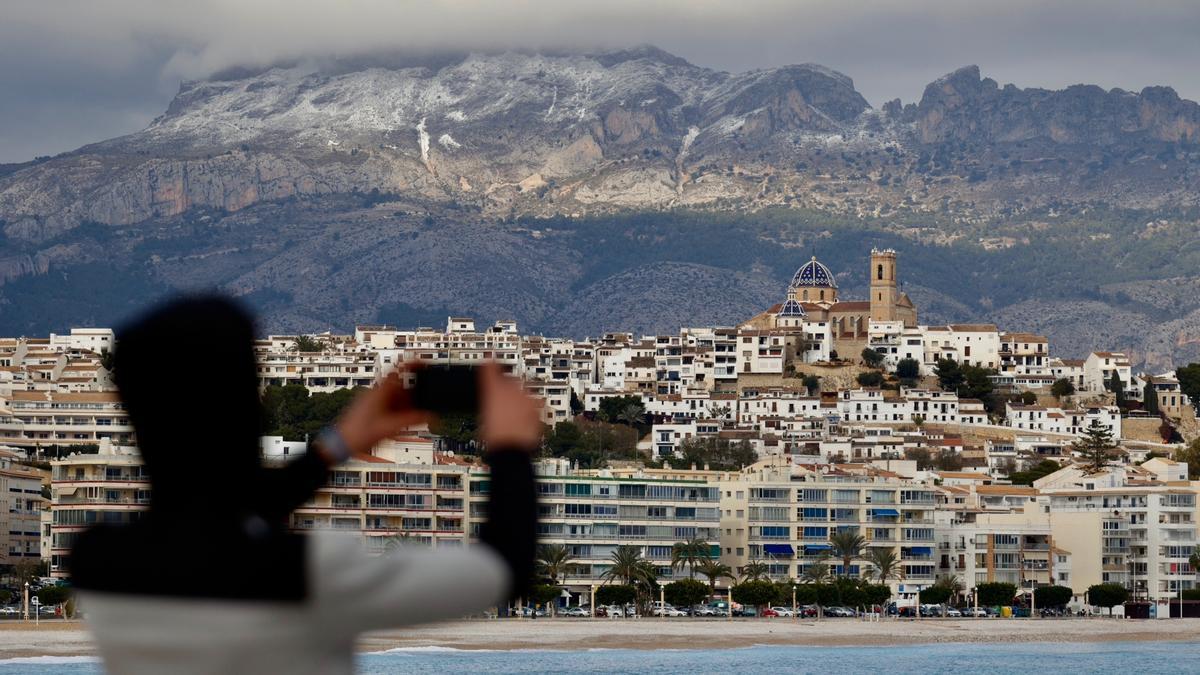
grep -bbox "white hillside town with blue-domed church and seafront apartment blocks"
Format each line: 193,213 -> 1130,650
0,250 -> 1200,611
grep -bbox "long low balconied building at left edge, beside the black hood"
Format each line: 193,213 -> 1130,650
0,392 -> 133,452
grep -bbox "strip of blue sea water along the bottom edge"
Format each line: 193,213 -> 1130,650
0,641 -> 1200,675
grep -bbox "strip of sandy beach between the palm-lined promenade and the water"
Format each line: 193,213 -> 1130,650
7,619 -> 1200,659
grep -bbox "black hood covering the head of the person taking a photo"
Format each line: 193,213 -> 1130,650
113,295 -> 263,516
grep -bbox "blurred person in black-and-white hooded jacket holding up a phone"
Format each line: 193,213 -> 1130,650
68,297 -> 541,675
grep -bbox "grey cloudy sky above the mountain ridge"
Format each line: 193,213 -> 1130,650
0,0 -> 1200,162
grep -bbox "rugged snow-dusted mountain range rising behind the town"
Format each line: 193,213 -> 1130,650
0,47 -> 1200,365
